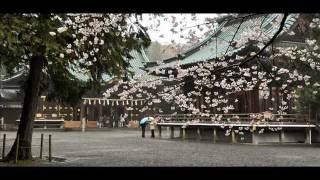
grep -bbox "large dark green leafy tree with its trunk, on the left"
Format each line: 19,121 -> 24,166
0,14 -> 150,161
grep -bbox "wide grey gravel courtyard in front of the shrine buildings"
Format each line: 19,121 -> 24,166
0,129 -> 320,167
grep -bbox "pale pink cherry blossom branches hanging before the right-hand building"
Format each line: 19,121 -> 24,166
104,14 -> 320,138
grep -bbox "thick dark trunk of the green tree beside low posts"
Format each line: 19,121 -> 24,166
4,56 -> 43,161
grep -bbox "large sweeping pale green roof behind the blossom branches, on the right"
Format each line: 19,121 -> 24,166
148,14 -> 296,70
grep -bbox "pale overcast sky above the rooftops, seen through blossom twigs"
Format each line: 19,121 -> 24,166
141,14 -> 218,44
